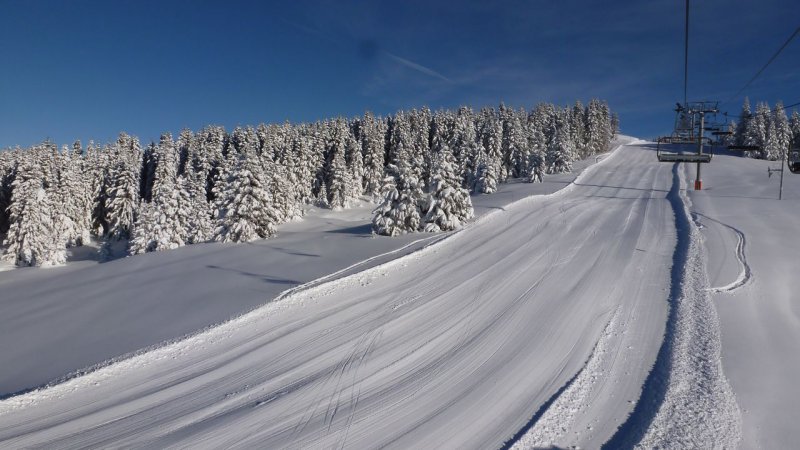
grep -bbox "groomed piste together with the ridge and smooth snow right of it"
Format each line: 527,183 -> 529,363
0,141 -> 800,448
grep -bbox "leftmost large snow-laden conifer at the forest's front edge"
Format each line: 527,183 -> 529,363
3,155 -> 67,266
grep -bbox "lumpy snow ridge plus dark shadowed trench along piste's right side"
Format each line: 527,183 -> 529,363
604,165 -> 742,449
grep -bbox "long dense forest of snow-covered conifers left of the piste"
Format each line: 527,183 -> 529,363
0,100 -> 617,266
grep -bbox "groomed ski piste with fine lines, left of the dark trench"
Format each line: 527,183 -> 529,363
0,140 -> 696,447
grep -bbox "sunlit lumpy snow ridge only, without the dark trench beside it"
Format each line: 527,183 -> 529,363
637,168 -> 743,449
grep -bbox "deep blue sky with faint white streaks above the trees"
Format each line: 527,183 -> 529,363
0,0 -> 800,148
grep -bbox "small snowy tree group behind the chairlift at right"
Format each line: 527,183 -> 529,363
730,97 -> 800,161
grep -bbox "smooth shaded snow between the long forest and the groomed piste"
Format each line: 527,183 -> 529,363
0,136 -> 632,398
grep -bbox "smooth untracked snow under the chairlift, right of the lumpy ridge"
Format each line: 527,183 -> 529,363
686,149 -> 800,448
